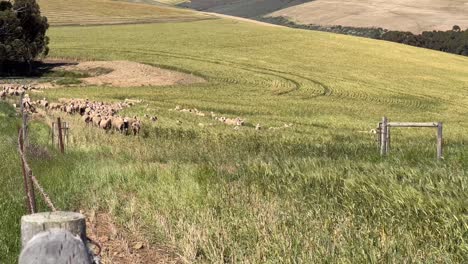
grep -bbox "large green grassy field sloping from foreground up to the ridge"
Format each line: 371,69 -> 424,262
0,7 -> 468,263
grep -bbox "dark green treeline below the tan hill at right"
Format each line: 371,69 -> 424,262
261,17 -> 468,56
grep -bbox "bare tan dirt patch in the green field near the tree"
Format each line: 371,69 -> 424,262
54,61 -> 205,87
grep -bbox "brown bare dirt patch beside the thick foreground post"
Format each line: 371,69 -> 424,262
86,212 -> 182,264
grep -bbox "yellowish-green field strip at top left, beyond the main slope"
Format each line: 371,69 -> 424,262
37,0 -> 210,25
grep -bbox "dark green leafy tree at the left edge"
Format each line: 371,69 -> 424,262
0,0 -> 49,73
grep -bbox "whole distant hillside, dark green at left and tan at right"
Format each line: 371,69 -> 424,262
173,0 -> 468,33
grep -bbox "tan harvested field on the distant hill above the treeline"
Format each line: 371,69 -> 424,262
269,0 -> 468,33
